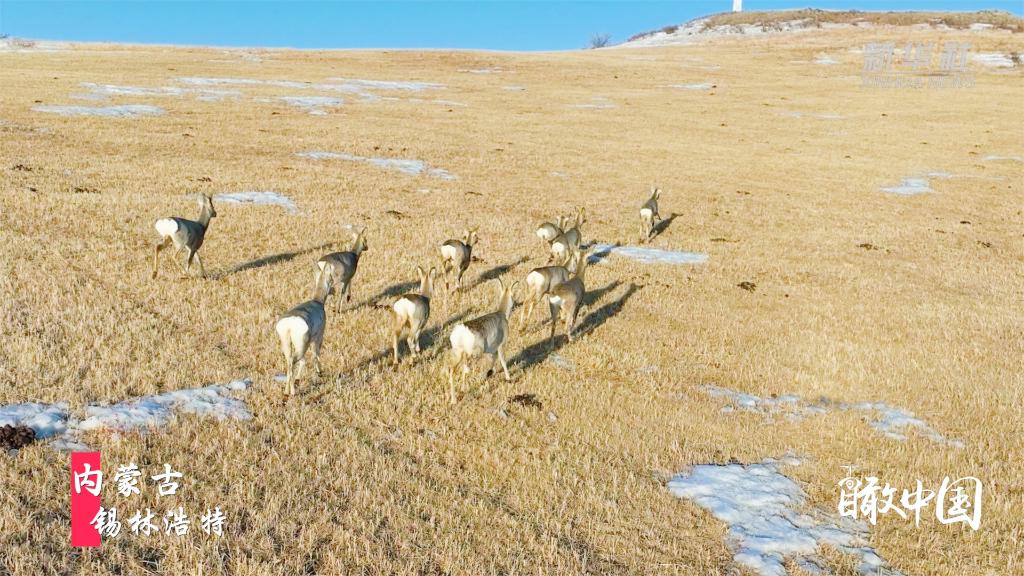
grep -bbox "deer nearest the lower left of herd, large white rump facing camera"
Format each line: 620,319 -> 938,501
273,274 -> 332,397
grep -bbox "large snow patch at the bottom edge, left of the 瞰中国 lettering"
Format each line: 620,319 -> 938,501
668,459 -> 899,576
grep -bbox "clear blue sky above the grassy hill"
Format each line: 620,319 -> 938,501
0,0 -> 1024,50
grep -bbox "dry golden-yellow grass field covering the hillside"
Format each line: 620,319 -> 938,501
0,17 -> 1024,576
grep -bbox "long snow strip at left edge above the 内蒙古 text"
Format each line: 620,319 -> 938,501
0,378 -> 252,450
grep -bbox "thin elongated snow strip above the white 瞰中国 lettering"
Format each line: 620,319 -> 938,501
700,384 -> 964,448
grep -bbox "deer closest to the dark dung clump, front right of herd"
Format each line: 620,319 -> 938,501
449,279 -> 519,404
